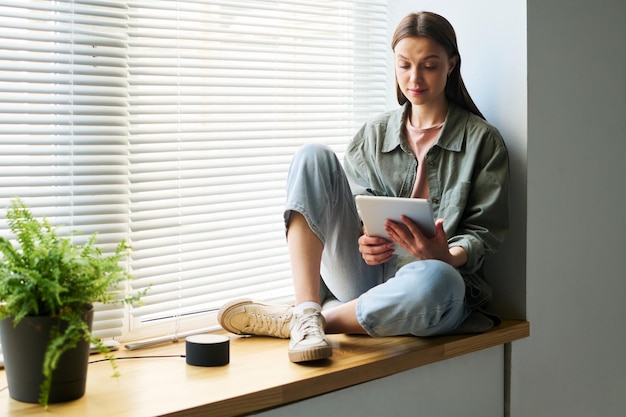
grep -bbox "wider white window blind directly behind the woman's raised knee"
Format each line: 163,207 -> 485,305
129,0 -> 388,338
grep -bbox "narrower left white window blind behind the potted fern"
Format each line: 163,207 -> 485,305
0,0 -> 128,337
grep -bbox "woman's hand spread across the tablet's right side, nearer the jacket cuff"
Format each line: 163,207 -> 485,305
385,216 -> 467,267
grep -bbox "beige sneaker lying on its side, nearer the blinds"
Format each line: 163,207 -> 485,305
217,299 -> 293,339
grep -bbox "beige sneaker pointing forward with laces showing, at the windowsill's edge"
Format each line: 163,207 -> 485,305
289,309 -> 333,362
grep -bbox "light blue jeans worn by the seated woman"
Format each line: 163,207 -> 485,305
285,144 -> 470,336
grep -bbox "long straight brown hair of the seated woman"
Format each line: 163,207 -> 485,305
391,12 -> 485,119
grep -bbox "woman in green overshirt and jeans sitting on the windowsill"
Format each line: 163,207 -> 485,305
218,12 -> 508,362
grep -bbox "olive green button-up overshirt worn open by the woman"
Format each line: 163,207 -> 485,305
344,103 -> 509,307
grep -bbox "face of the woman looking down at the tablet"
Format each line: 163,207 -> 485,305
394,37 -> 457,106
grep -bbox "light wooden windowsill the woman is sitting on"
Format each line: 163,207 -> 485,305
0,320 -> 530,417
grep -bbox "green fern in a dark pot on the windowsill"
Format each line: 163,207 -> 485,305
0,198 -> 138,407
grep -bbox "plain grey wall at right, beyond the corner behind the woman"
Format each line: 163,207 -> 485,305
511,0 -> 626,417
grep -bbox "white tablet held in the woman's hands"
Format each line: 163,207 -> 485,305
355,195 -> 435,255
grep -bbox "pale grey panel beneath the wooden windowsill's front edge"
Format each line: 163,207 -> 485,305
258,347 -> 504,417
